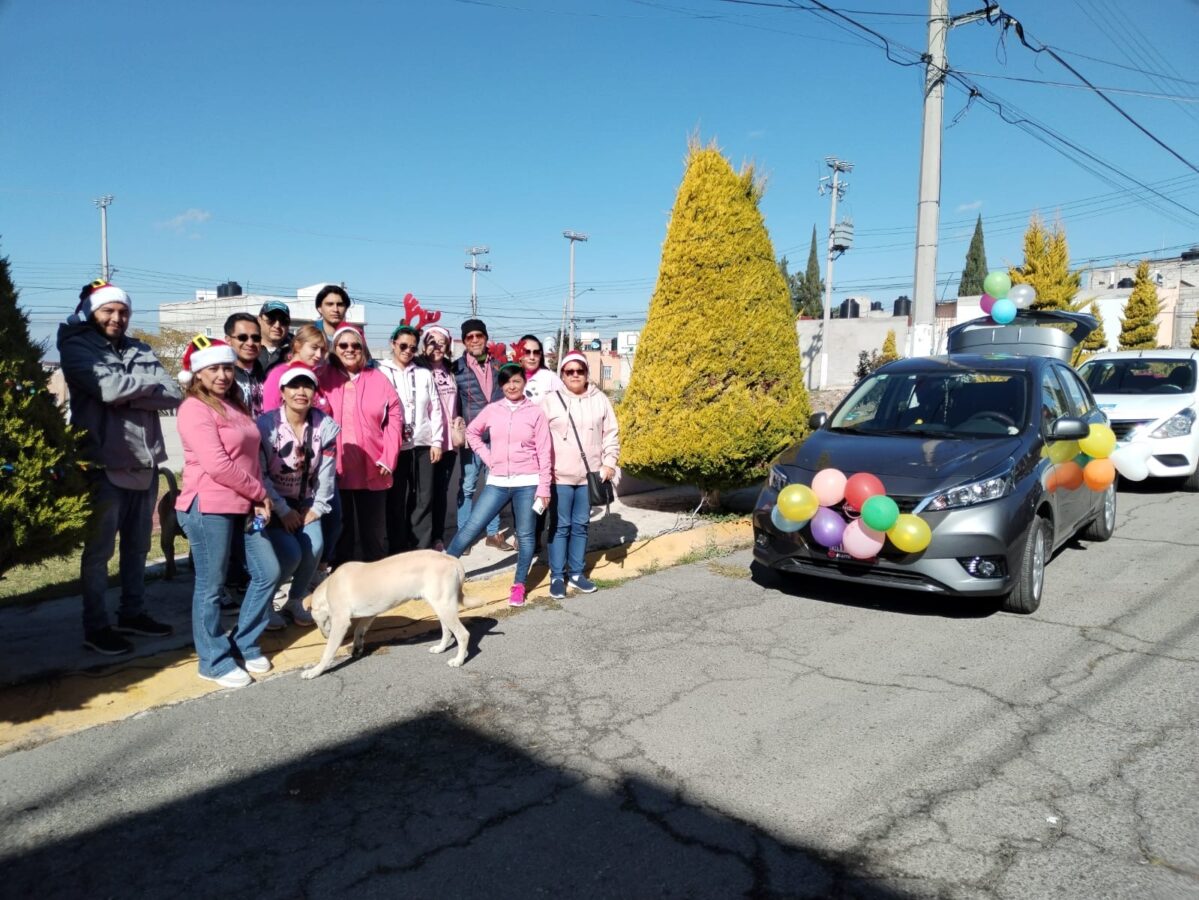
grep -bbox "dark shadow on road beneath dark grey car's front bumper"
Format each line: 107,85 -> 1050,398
749,562 -> 999,618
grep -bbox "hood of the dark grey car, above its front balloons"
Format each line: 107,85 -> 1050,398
776,430 -> 1022,496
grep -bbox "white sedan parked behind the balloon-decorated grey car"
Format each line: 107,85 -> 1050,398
1078,350 -> 1199,490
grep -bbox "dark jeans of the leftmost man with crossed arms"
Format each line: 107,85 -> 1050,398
79,470 -> 158,634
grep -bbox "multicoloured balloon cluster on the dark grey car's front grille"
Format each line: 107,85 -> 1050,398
770,469 -> 933,560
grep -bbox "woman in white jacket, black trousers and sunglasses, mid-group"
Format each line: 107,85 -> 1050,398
379,325 -> 445,554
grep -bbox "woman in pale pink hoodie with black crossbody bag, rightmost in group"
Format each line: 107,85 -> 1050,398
541,350 -> 620,599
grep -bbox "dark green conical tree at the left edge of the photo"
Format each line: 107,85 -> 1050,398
0,256 -> 89,575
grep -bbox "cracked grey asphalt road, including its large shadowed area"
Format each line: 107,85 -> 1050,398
0,488 -> 1199,900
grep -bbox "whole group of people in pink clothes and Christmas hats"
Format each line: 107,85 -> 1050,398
58,282 -> 620,687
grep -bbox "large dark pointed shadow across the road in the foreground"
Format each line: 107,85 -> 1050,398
0,708 -> 906,900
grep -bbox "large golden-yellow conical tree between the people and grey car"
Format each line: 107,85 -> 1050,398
620,144 -> 809,506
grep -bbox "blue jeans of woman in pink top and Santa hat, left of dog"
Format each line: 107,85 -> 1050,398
179,499 -> 279,678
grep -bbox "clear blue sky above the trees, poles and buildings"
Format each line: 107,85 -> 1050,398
0,0 -> 1199,352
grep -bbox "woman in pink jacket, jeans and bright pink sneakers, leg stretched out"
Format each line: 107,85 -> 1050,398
446,363 -> 552,606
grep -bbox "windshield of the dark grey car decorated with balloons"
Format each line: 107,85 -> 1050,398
829,372 -> 1028,437
